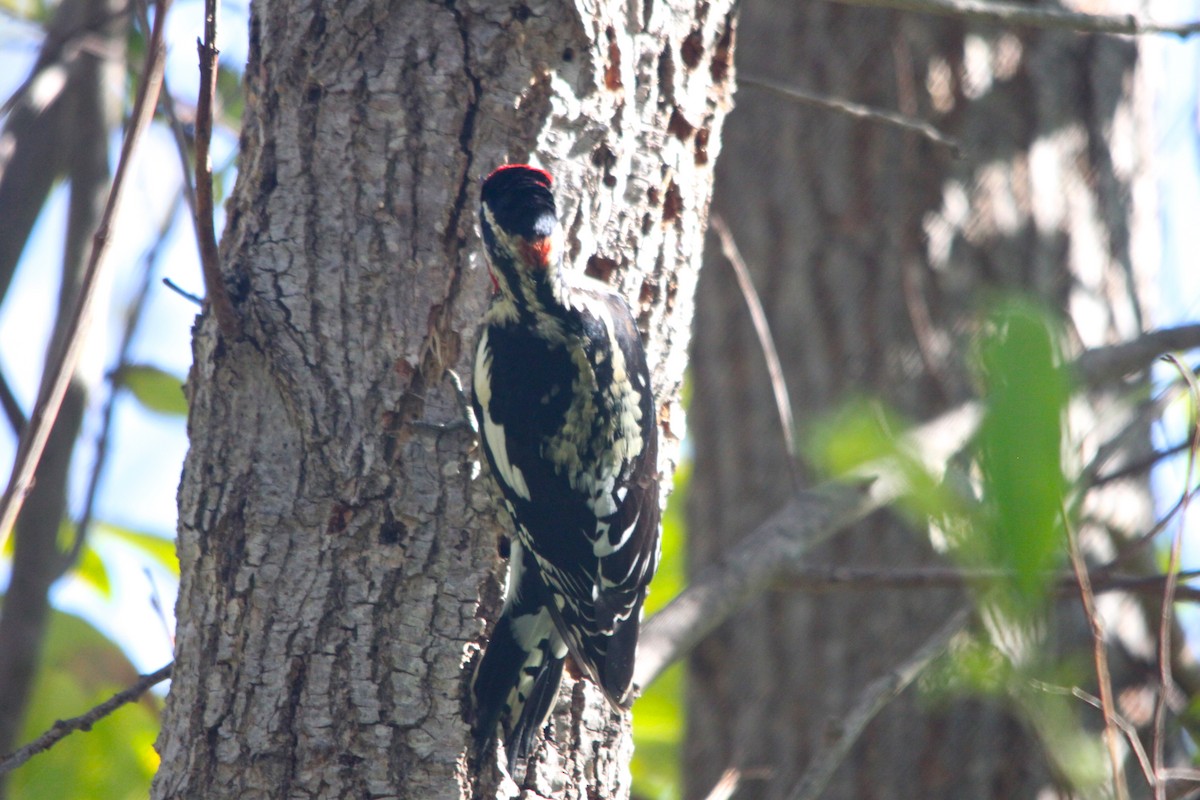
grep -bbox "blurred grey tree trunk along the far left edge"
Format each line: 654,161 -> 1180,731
0,0 -> 128,798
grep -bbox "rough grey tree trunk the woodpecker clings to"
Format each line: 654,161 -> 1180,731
154,0 -> 733,799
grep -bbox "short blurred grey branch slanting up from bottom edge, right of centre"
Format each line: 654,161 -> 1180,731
787,608 -> 971,800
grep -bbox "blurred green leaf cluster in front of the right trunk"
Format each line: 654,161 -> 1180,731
809,300 -> 1106,788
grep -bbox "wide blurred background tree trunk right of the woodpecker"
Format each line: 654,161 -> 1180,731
684,0 -> 1166,799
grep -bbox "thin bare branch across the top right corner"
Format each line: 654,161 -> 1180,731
833,0 -> 1200,37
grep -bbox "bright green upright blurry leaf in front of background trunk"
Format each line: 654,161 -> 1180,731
979,301 -> 1070,610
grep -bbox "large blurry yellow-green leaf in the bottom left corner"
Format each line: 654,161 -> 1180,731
8,612 -> 161,800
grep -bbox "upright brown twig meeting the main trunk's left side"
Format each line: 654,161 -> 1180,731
196,0 -> 239,338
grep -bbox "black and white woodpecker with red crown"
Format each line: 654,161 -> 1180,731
473,164 -> 659,775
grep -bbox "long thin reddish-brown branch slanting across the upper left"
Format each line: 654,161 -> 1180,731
0,0 -> 169,548
